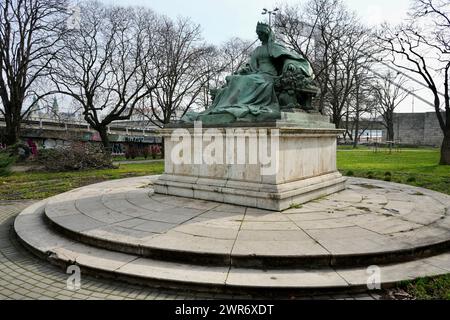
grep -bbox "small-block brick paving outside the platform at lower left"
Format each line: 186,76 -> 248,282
0,201 -> 381,300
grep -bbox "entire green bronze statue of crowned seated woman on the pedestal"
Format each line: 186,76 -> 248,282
182,23 -> 318,124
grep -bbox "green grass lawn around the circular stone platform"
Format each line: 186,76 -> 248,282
0,147 -> 450,300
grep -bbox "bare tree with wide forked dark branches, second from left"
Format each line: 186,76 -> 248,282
52,1 -> 158,148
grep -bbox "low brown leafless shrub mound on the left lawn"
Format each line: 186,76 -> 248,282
37,142 -> 114,171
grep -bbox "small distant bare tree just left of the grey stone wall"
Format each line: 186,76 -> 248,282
372,71 -> 408,141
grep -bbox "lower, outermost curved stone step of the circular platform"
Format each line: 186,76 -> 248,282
14,201 -> 450,293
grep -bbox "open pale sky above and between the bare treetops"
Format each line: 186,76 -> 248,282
101,0 -> 433,112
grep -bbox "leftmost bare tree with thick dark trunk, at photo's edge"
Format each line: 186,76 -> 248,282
0,0 -> 67,145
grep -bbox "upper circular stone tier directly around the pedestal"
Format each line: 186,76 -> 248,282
39,177 -> 450,269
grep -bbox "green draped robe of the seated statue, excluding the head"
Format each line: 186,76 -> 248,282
183,41 -> 313,122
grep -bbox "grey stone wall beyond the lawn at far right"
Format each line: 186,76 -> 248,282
383,112 -> 444,147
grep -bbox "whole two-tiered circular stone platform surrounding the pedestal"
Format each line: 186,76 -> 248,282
15,176 -> 450,296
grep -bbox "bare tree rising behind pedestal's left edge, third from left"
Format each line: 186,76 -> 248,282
139,16 -> 215,127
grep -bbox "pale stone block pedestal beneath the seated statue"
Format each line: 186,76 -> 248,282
155,113 -> 345,211
